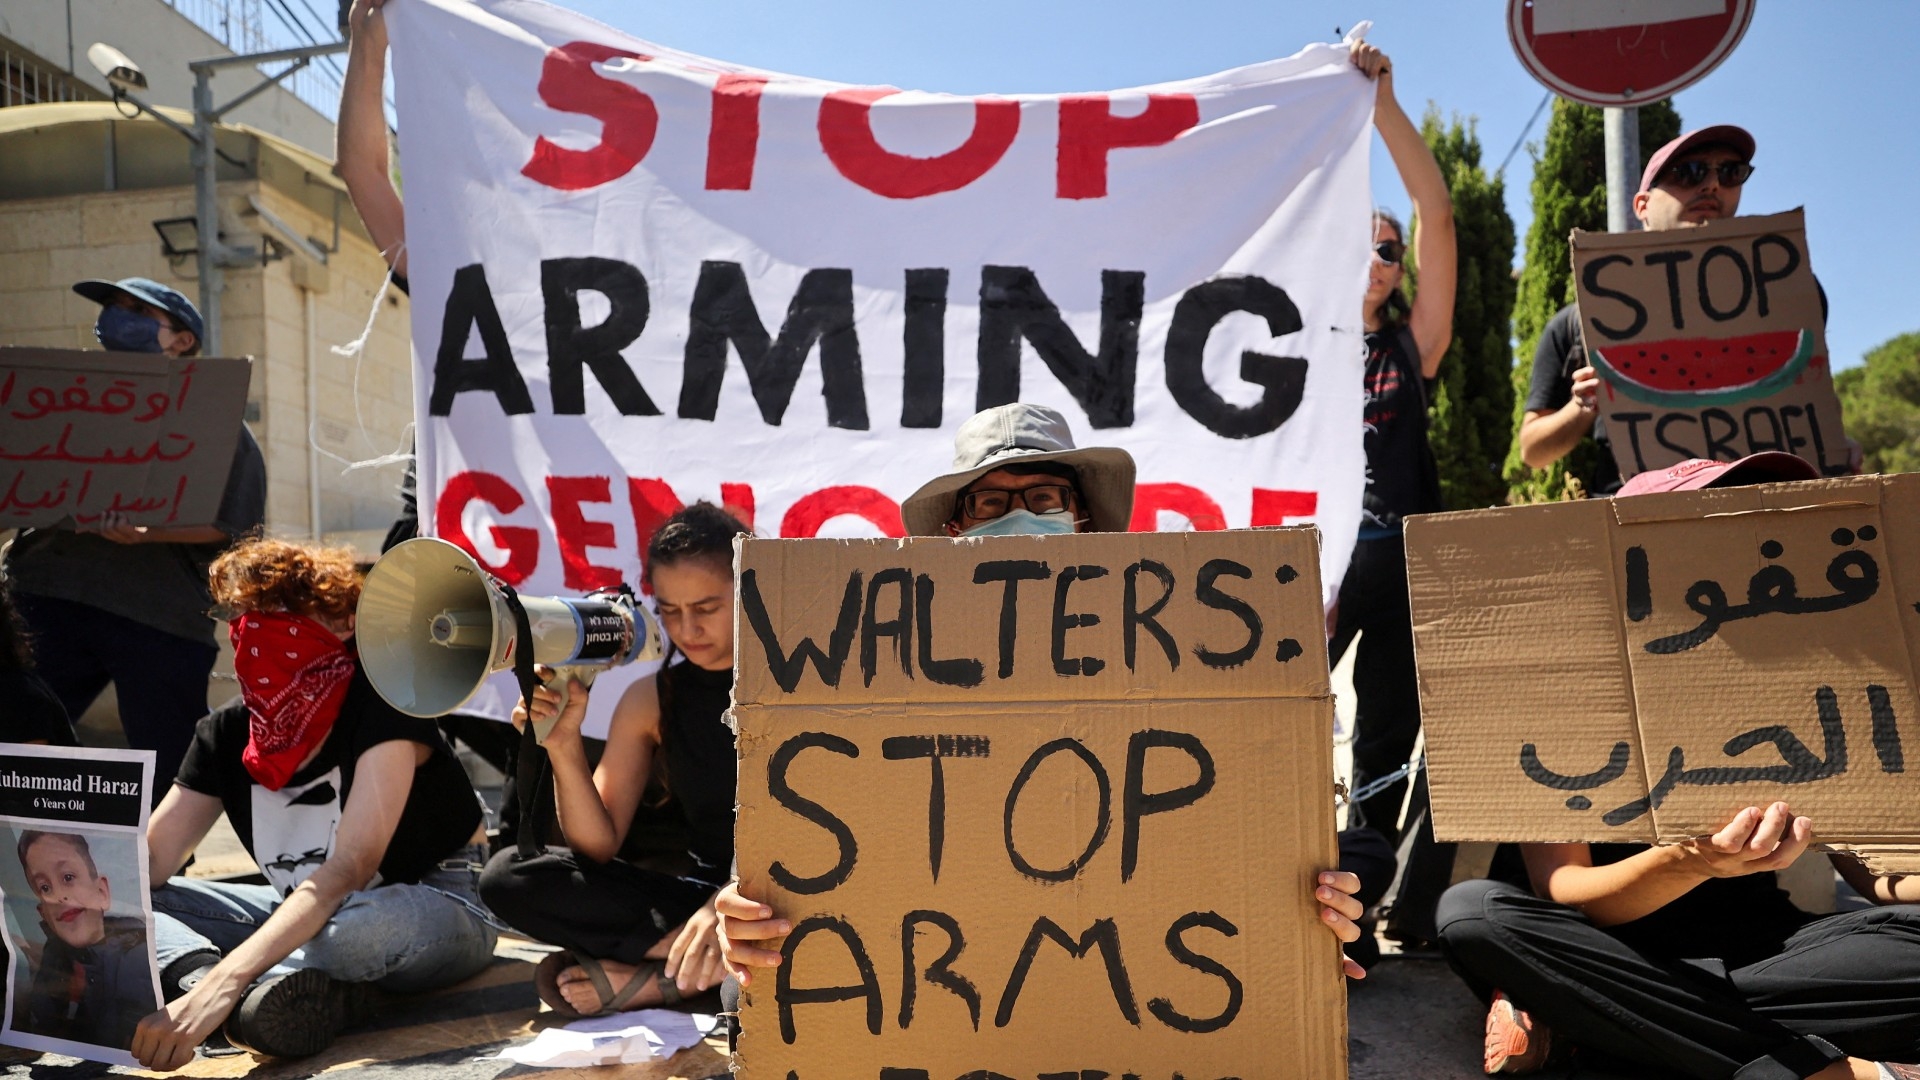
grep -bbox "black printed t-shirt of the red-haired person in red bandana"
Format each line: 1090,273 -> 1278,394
175,669 -> 480,896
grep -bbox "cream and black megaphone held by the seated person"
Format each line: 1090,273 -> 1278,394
355,536 -> 664,742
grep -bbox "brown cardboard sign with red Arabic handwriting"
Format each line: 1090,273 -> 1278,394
0,348 -> 252,528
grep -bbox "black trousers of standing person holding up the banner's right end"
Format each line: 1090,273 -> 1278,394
1327,536 -> 1421,842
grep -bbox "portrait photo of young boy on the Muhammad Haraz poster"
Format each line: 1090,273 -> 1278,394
0,828 -> 157,1049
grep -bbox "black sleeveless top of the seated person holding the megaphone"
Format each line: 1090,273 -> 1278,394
660,661 -> 739,886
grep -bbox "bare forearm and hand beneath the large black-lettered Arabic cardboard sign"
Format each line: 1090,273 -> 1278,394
1521,803 -> 1812,926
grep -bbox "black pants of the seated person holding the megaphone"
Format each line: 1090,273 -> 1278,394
480,847 -> 718,965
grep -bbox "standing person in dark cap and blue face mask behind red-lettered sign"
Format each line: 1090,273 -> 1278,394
4,277 -> 267,801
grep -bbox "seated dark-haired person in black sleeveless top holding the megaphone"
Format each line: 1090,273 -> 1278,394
480,502 -> 747,1019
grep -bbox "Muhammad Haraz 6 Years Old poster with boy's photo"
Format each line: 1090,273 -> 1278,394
0,746 -> 161,1067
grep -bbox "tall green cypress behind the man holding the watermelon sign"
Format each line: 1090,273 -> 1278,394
1505,98 -> 1680,502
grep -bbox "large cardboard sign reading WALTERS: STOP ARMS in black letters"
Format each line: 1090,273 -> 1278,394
733,528 -> 1346,1080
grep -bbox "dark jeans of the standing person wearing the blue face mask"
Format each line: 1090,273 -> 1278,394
13,592 -> 221,791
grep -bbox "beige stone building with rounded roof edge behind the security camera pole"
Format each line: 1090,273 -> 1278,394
0,102 -> 413,553
